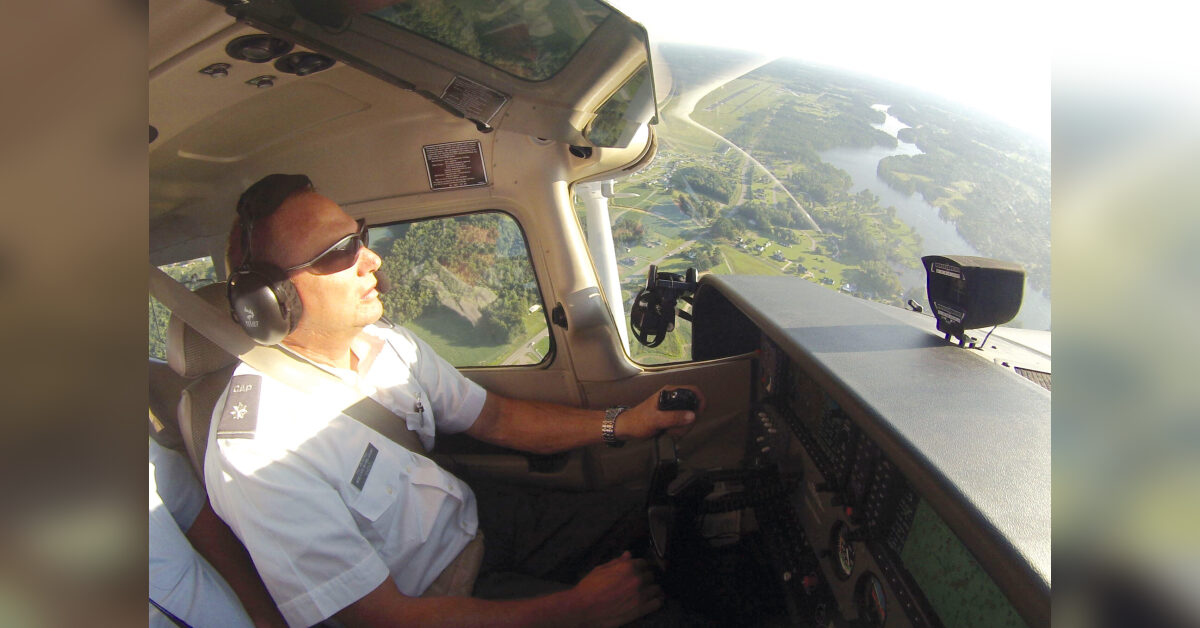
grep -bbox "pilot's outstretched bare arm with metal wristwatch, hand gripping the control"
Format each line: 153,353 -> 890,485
467,385 -> 704,454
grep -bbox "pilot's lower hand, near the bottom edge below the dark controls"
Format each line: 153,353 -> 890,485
569,551 -> 662,626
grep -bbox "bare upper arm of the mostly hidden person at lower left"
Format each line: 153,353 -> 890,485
185,500 -> 287,628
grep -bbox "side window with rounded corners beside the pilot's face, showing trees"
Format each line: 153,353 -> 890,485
371,211 -> 551,366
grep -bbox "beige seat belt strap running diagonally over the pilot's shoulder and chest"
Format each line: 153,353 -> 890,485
149,264 -> 428,456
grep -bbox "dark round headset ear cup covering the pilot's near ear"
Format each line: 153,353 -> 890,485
229,264 -> 304,345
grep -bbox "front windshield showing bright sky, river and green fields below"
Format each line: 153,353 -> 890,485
600,1 -> 1051,363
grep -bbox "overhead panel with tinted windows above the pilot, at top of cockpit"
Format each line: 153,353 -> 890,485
228,0 -> 658,148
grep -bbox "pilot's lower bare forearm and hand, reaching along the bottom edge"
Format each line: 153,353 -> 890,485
336,552 -> 662,627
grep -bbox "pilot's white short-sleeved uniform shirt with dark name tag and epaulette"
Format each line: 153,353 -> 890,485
204,327 -> 487,626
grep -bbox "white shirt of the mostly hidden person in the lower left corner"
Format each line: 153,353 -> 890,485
146,439 -> 253,628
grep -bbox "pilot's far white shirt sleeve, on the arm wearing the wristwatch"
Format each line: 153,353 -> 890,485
395,328 -> 487,433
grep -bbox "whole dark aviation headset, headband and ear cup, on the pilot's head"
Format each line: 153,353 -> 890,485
228,174 -> 313,345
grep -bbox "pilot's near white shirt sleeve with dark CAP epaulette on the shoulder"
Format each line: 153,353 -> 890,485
205,405 -> 389,626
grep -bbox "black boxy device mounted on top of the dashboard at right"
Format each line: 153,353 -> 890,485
920,255 -> 1025,347
